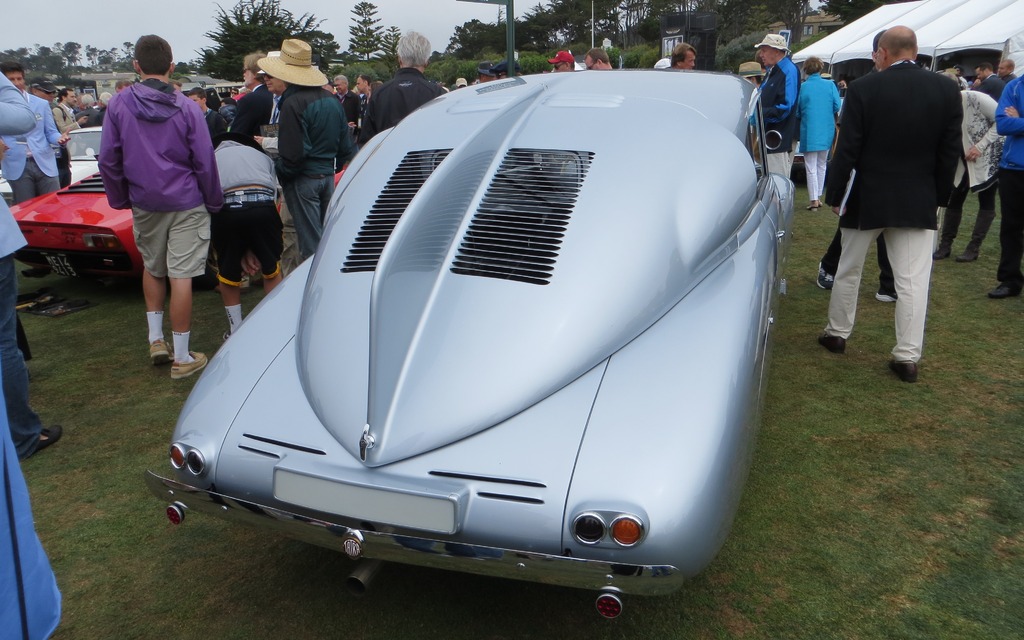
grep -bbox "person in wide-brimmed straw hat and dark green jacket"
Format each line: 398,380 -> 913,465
258,39 -> 355,259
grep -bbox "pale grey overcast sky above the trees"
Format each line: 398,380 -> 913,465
0,0 -> 524,61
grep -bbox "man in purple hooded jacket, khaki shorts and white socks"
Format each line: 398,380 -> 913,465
99,36 -> 223,380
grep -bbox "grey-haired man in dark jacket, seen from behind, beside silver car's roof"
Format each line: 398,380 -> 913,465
359,31 -> 444,144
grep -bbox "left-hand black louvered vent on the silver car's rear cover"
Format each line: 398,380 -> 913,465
341,148 -> 452,273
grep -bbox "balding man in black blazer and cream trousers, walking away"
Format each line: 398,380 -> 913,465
818,27 -> 964,382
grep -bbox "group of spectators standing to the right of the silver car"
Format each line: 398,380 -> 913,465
738,27 -> 1024,382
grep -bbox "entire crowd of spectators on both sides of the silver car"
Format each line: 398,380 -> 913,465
0,19 -> 1024,624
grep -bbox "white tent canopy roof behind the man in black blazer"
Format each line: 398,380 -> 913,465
793,0 -> 1024,65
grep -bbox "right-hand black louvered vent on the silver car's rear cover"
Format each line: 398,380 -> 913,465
452,148 -> 594,285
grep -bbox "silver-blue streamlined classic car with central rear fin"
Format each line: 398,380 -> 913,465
146,71 -> 793,616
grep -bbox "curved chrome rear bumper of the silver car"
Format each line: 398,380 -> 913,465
145,471 -> 684,595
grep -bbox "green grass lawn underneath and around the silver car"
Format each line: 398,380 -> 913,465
22,182 -> 1024,640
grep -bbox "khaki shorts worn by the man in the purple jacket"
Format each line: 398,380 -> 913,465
132,205 -> 210,279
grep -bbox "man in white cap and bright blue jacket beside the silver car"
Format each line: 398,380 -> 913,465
755,34 -> 800,177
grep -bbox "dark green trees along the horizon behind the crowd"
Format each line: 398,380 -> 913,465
0,0 -> 907,82
